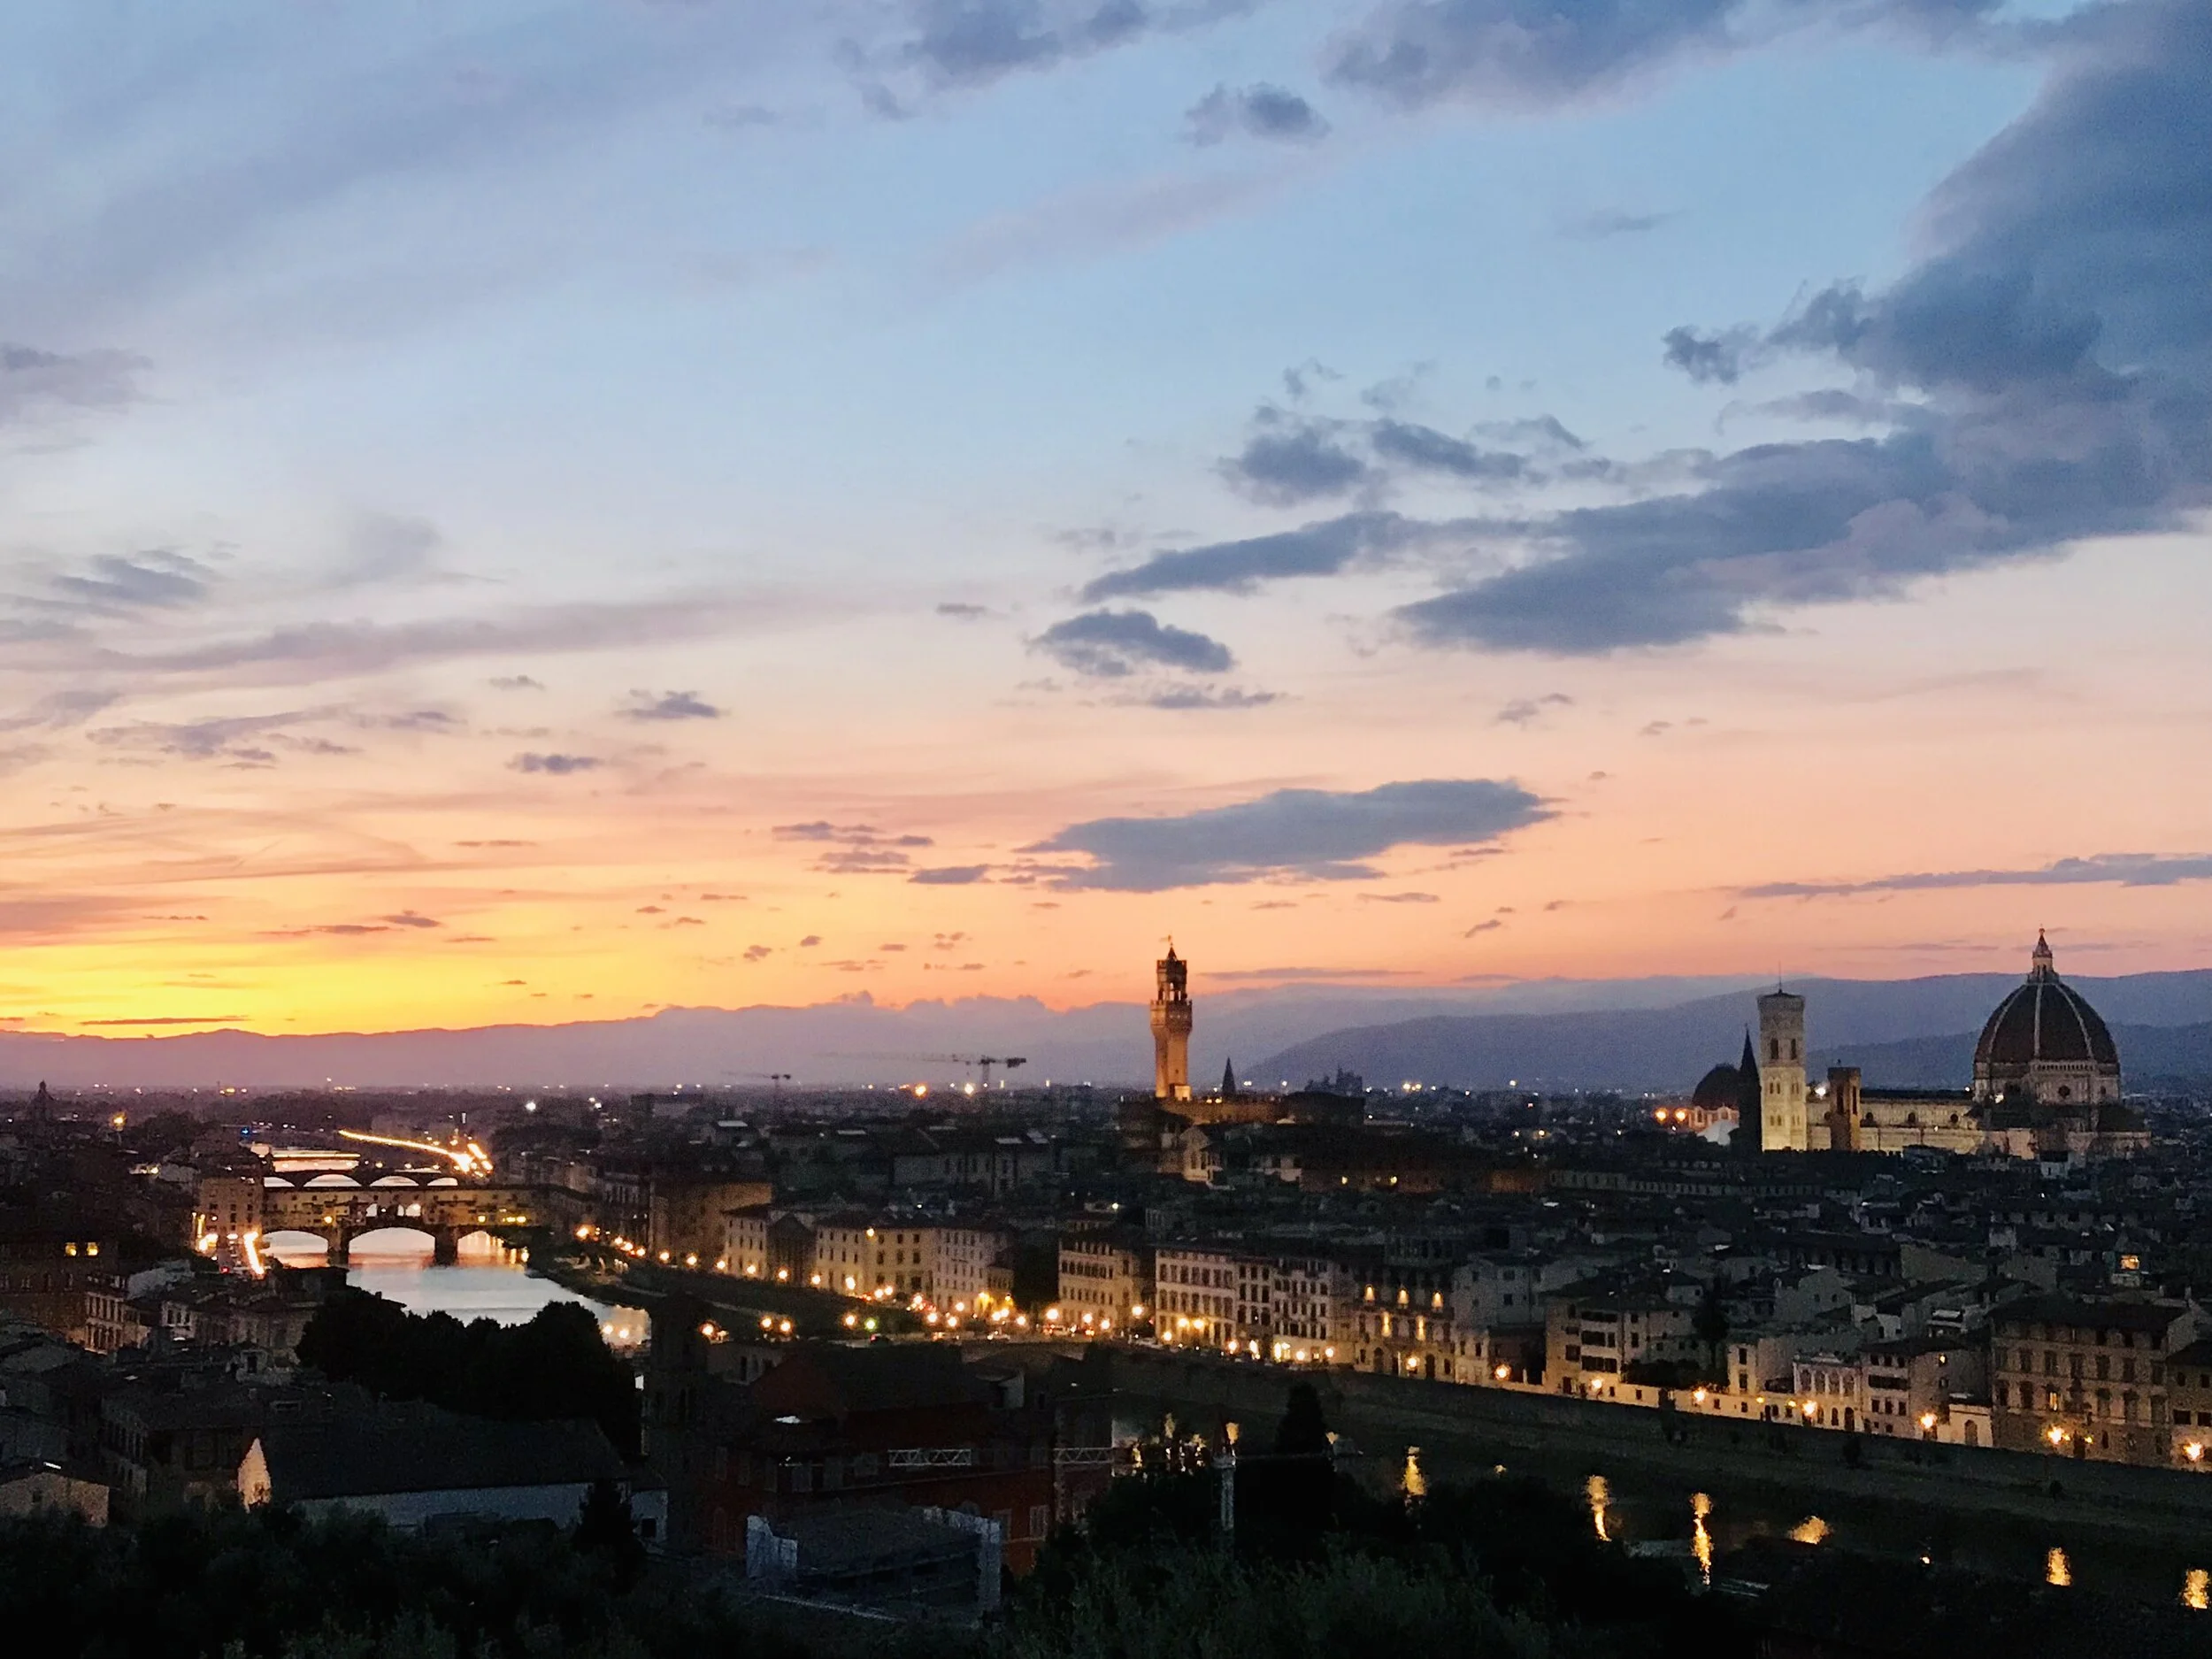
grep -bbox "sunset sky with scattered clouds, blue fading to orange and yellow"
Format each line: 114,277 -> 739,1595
0,0 -> 2212,1035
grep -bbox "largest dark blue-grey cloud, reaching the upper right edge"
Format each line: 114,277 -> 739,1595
1401,0 -> 2212,653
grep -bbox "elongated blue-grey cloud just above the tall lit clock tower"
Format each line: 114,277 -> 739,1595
1025,779 -> 1553,894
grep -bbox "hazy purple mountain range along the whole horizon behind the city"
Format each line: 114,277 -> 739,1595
0,969 -> 2212,1091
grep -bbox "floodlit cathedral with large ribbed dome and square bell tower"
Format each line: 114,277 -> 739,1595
1699,936 -> 2150,1159
